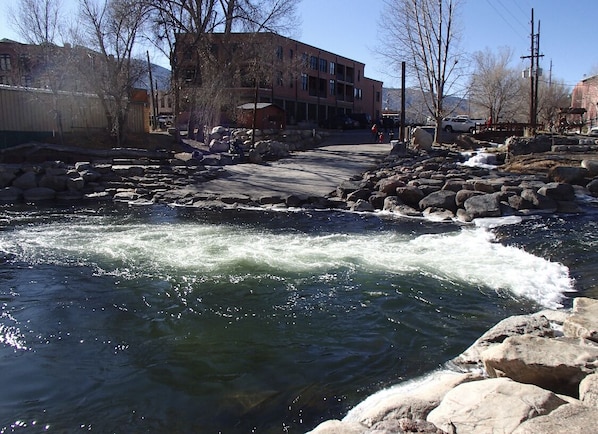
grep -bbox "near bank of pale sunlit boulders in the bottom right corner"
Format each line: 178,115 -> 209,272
311,298 -> 598,434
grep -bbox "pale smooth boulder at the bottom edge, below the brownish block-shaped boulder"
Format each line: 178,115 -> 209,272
427,378 -> 566,434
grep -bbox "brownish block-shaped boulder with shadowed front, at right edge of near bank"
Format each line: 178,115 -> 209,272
481,335 -> 598,397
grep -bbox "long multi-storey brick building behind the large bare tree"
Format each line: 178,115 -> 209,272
171,33 -> 382,126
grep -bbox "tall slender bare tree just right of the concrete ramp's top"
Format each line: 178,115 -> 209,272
380,0 -> 461,142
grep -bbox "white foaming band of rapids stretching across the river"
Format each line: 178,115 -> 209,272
0,221 -> 573,308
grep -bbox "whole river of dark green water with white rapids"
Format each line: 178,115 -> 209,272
0,202 -> 598,433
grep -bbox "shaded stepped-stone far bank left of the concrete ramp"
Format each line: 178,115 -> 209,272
0,128 -> 325,206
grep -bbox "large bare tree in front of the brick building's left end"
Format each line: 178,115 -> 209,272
150,0 -> 299,137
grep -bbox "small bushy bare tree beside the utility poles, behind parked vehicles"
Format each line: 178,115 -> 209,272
469,47 -> 525,123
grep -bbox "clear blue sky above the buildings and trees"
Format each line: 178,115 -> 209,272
0,0 -> 598,87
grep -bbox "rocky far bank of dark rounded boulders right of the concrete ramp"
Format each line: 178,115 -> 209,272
336,133 -> 598,222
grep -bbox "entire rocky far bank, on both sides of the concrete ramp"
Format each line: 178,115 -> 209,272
0,131 -> 598,222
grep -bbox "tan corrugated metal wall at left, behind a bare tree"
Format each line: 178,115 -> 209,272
0,86 -> 148,133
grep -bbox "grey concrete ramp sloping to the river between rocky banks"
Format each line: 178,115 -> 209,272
194,132 -> 391,200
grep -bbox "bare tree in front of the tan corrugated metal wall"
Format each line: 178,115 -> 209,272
79,0 -> 147,145
